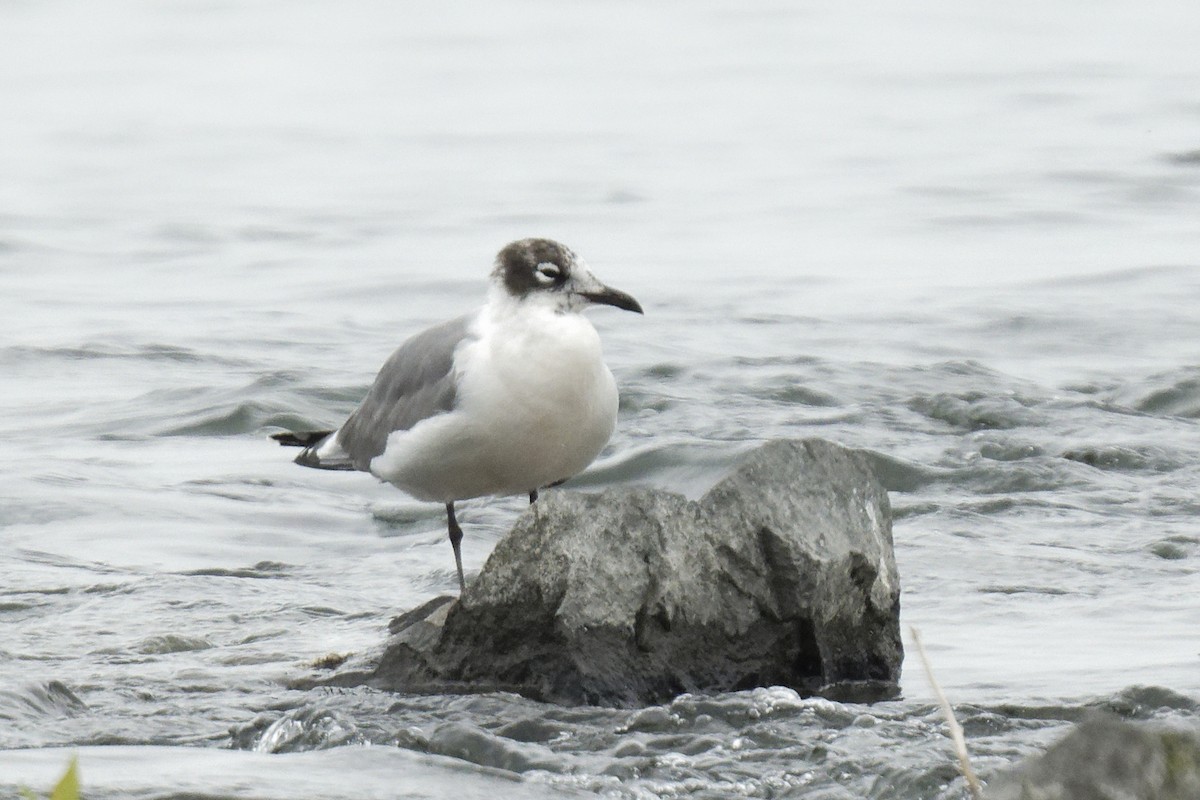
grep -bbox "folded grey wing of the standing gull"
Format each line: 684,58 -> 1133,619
337,312 -> 478,471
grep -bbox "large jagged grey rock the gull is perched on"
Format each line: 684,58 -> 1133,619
331,439 -> 904,705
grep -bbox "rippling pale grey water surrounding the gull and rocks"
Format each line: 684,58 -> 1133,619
0,0 -> 1200,800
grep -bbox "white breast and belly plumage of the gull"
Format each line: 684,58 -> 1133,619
371,304 -> 617,503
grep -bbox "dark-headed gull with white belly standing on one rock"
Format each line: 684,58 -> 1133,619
272,239 -> 642,591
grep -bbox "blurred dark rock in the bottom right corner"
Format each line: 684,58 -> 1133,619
986,715 -> 1200,800
